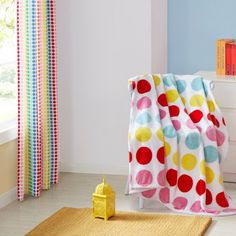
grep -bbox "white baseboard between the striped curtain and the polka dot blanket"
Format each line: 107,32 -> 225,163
60,163 -> 128,175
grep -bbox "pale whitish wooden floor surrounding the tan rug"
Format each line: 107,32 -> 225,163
0,173 -> 236,236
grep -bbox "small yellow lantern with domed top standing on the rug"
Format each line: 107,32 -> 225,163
93,178 -> 115,220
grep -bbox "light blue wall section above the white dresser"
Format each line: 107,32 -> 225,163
168,0 -> 236,74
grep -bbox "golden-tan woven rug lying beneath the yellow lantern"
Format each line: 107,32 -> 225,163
27,208 -> 212,236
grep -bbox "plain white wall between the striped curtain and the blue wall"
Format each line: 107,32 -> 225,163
57,0 -> 166,174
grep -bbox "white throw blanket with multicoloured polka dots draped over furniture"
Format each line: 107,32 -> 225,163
128,74 -> 236,215
